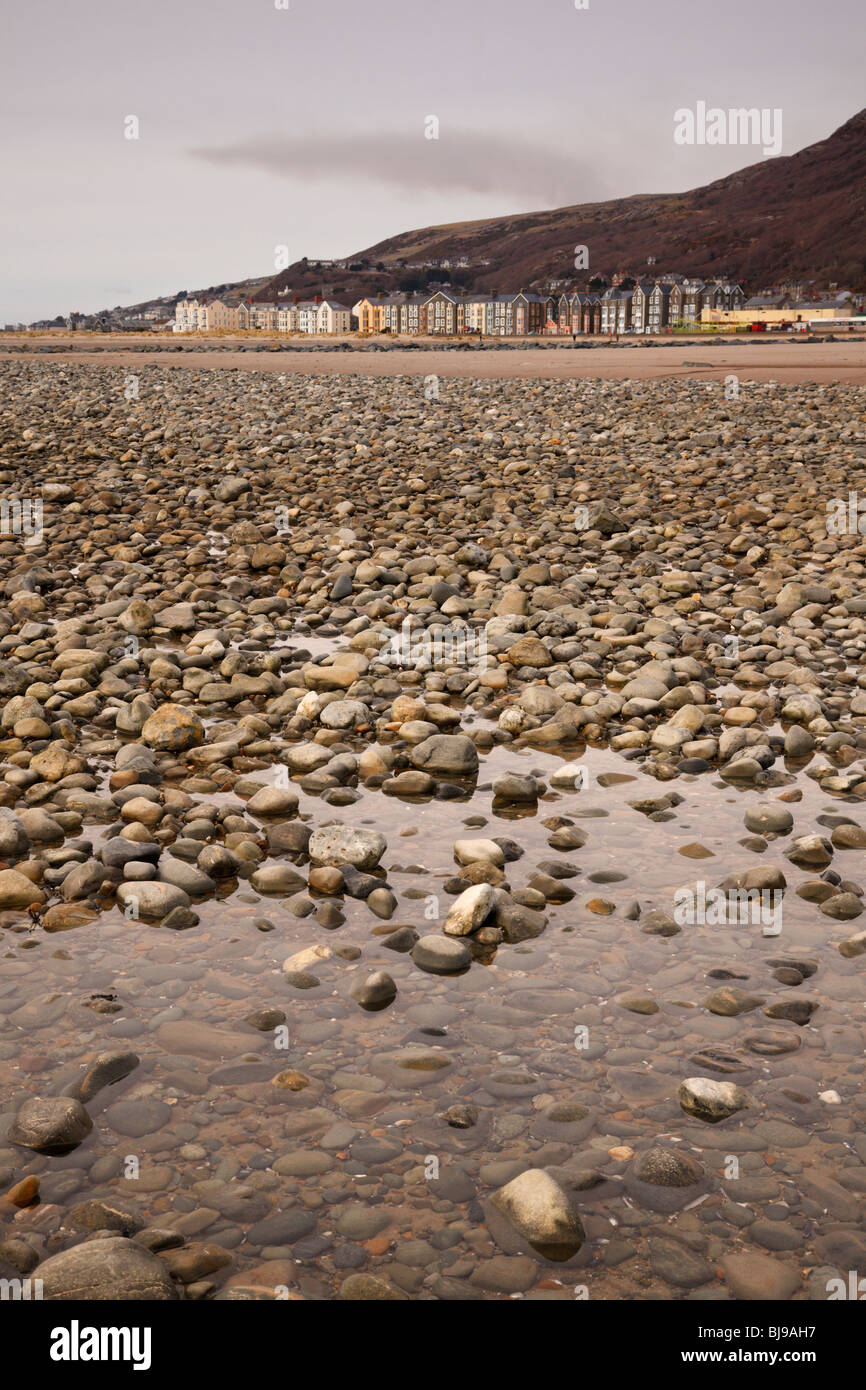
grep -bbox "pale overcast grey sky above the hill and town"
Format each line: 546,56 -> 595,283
0,0 -> 866,322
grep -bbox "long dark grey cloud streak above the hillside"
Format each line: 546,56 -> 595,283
190,122 -> 605,206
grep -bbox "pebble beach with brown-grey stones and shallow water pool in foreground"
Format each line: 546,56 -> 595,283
0,361 -> 866,1301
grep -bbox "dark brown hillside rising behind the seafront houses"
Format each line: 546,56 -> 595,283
262,110 -> 866,303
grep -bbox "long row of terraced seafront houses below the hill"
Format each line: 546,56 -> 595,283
174,275 -> 856,338
